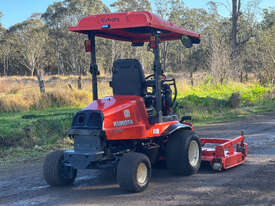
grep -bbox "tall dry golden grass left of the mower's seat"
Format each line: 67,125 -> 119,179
0,76 -> 111,112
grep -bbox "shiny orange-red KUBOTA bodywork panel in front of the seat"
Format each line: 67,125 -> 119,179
84,95 -> 179,140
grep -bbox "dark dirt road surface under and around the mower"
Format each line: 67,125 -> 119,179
0,112 -> 275,206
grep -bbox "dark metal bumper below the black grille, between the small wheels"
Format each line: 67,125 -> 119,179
64,150 -> 104,169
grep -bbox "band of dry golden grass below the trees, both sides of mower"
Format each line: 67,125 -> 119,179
0,73 -> 275,112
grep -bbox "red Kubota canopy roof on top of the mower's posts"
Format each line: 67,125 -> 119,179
69,11 -> 201,43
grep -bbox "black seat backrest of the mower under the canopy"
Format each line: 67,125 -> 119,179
111,59 -> 145,96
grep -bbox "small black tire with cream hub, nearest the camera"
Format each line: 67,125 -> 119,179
117,152 -> 152,192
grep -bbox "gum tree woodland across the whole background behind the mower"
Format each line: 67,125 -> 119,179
0,0 -> 275,88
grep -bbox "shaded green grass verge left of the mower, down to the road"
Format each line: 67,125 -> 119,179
0,107 -> 79,167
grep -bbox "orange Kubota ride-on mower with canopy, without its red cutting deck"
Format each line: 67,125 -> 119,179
43,12 -> 248,192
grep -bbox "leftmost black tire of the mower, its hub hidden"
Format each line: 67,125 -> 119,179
43,151 -> 77,186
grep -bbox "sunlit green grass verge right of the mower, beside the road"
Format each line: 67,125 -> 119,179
176,82 -> 275,124
